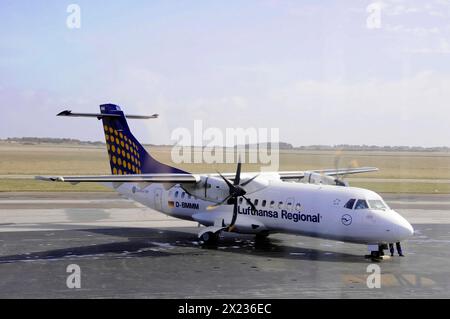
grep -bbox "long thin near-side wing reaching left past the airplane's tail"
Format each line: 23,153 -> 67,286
35,174 -> 200,184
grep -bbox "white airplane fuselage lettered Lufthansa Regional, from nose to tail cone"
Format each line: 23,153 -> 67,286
110,180 -> 414,244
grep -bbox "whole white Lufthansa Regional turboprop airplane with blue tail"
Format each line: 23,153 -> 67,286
36,104 -> 414,258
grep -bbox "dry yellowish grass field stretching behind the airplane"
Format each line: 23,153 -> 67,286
0,143 -> 450,193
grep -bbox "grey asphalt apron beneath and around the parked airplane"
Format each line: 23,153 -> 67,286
0,193 -> 450,298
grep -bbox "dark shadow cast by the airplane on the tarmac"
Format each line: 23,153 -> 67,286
0,224 -> 367,264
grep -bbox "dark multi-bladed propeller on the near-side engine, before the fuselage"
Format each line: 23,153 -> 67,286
207,160 -> 259,231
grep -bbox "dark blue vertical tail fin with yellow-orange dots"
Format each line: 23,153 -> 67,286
100,104 -> 186,175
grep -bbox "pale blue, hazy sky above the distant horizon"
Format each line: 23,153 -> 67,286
0,0 -> 450,146
